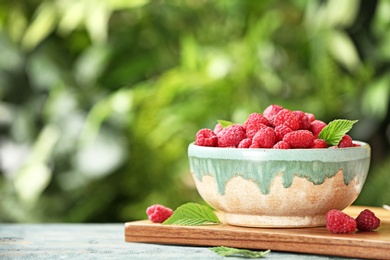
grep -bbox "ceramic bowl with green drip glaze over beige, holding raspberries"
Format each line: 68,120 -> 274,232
188,141 -> 371,228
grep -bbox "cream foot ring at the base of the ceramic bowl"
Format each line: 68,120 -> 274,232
224,213 -> 326,228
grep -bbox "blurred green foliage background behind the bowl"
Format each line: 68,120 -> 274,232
0,0 -> 390,222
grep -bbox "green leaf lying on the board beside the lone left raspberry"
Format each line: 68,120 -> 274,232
163,202 -> 221,226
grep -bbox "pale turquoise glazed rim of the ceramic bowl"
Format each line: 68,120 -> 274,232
188,141 -> 371,162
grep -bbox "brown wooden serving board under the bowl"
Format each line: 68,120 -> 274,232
125,206 -> 390,259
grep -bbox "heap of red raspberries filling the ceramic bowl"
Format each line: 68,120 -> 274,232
195,105 -> 355,149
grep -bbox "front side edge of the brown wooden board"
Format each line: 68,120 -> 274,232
125,222 -> 390,259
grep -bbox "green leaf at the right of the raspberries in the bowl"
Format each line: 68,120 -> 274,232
318,119 -> 358,145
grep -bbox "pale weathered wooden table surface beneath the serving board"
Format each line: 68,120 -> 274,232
0,224 -> 354,259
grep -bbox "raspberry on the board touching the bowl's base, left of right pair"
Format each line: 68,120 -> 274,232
326,209 -> 356,233
